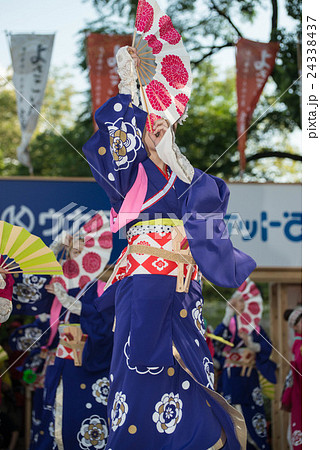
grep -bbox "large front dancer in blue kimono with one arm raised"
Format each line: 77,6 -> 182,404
83,48 -> 255,450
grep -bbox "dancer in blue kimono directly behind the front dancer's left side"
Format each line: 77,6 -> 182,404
36,280 -> 114,450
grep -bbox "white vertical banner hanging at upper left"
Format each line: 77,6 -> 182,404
9,34 -> 54,172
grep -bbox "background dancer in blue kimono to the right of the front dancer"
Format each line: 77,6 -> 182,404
214,291 -> 276,450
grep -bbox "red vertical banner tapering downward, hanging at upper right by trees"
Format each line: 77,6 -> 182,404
236,38 -> 279,171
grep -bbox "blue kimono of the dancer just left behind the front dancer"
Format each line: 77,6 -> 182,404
36,283 -> 114,450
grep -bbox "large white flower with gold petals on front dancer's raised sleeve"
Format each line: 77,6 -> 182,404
106,117 -> 142,171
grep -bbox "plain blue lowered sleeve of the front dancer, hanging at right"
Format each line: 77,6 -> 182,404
182,169 -> 256,288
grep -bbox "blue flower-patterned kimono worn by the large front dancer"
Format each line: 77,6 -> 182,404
83,94 -> 255,450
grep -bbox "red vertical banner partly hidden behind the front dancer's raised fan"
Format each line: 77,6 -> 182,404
87,33 -> 132,131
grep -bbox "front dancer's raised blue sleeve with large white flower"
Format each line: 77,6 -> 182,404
83,94 -> 147,212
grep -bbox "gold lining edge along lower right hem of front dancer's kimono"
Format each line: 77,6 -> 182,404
172,342 -> 247,450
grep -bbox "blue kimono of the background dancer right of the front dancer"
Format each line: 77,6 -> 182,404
214,321 -> 276,450
